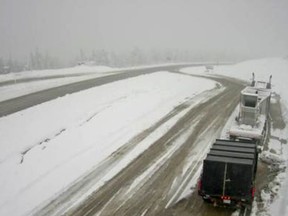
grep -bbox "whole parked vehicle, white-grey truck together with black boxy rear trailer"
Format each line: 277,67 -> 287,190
198,73 -> 272,208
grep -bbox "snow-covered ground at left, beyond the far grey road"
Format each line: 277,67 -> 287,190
0,65 -> 117,102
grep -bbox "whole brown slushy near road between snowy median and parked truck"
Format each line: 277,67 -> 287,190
35,74 -> 244,216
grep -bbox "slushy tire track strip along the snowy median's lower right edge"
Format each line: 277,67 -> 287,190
33,87 -> 215,216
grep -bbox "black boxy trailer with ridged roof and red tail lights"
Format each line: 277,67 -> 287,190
198,140 -> 258,207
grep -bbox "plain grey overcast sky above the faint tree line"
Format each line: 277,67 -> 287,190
0,0 -> 288,62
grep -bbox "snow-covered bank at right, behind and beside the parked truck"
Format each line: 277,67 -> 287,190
181,58 -> 288,216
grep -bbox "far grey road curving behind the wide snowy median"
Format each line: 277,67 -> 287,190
0,64 -> 201,117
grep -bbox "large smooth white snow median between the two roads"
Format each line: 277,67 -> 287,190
0,72 -> 216,216
